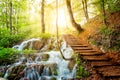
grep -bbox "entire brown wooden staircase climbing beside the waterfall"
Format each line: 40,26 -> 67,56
63,34 -> 120,80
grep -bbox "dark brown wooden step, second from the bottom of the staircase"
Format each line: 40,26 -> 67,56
90,61 -> 113,67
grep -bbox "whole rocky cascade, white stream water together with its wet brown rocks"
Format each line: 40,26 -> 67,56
1,38 -> 77,80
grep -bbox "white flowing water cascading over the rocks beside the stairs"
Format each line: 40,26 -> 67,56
4,39 -> 76,80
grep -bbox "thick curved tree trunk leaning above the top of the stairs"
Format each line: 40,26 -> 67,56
66,0 -> 83,33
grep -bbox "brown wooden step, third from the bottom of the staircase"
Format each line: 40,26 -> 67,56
83,56 -> 108,61
